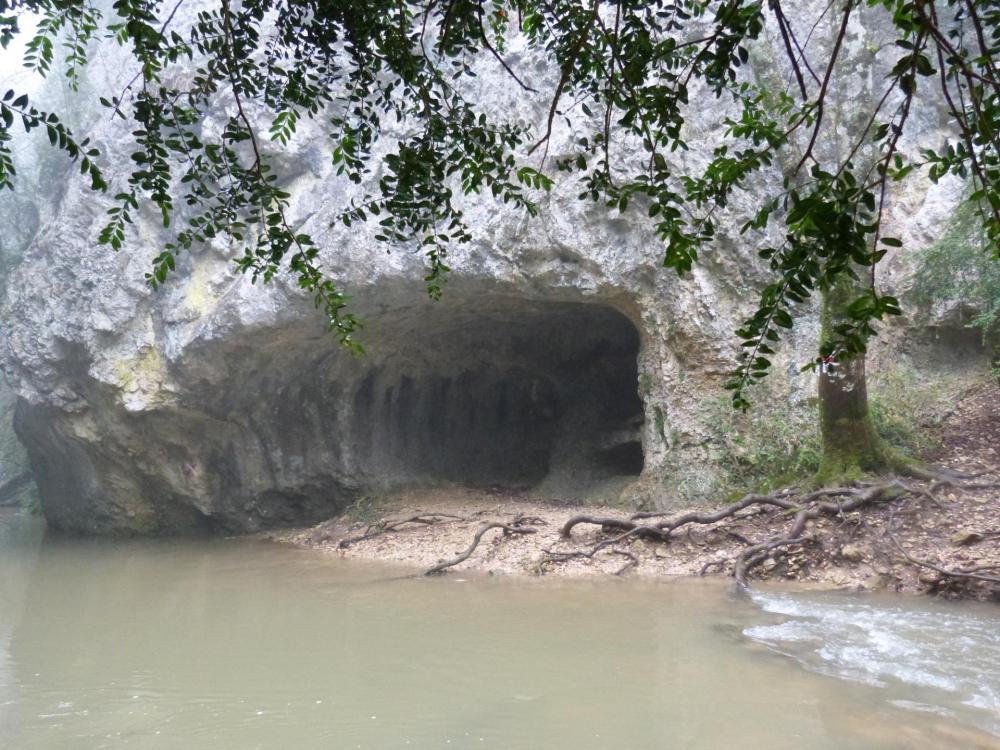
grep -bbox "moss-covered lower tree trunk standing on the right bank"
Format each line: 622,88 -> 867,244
817,280 -> 900,484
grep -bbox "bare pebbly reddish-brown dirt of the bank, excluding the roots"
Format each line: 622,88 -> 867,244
272,382 -> 1000,600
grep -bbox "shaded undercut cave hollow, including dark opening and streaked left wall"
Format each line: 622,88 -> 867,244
9,292 -> 643,531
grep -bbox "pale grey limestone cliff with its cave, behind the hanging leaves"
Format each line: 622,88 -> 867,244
0,4 -> 984,533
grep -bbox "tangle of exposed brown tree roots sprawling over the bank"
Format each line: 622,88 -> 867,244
298,474 -> 1000,595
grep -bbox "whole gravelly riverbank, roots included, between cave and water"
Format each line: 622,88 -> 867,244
270,386 -> 1000,601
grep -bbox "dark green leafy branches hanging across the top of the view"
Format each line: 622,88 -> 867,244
0,0 -> 1000,409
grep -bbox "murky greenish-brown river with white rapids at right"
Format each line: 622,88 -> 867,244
0,514 -> 1000,750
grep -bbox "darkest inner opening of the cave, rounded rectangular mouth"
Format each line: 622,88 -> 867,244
351,298 -> 643,495
